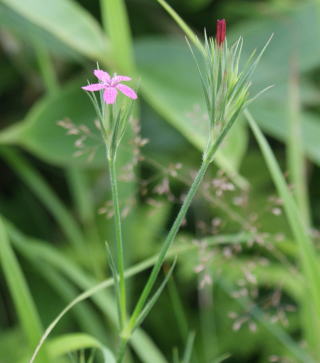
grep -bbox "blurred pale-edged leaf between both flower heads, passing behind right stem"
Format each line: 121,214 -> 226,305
135,38 -> 248,189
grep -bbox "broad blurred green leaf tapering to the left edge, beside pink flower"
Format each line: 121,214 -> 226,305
0,81 -> 104,167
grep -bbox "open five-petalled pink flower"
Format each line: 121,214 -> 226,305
81,69 -> 138,105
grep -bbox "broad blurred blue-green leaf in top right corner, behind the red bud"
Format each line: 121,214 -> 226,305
228,1 -> 320,85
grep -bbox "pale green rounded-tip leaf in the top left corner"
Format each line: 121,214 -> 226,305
1,0 -> 108,60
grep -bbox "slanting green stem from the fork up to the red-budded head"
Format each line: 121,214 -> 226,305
123,159 -> 210,337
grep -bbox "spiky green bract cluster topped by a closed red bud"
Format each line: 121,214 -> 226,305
188,19 -> 272,161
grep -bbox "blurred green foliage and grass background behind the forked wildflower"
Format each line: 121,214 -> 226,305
0,0 -> 320,363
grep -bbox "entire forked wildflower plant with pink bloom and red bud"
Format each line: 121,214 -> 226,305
31,19 -> 270,363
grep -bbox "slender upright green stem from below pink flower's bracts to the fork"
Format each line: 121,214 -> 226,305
108,157 -> 127,328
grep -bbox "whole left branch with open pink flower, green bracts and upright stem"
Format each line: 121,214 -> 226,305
82,69 -> 138,336
